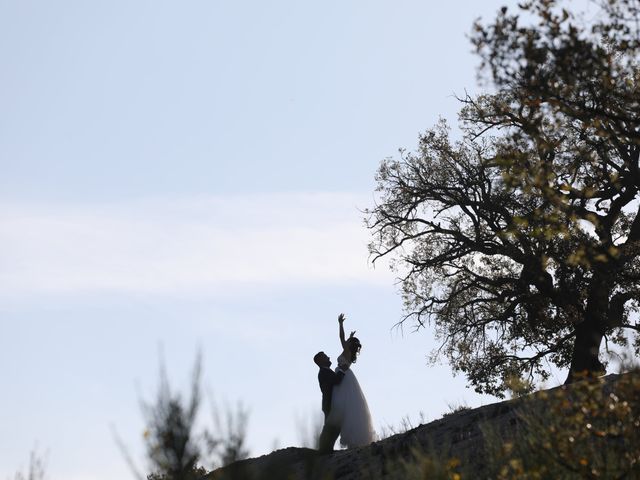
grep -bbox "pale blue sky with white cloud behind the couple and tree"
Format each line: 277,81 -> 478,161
0,0 -> 559,480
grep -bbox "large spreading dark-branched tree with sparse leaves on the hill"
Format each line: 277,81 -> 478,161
367,0 -> 640,396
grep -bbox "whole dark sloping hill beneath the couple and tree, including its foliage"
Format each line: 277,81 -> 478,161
205,373 -> 640,480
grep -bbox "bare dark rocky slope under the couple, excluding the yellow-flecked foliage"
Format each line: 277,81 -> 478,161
205,375 -> 640,480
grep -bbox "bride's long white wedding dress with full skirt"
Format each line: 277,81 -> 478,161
331,355 -> 376,448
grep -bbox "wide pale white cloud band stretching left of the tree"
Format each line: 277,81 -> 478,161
0,193 -> 390,295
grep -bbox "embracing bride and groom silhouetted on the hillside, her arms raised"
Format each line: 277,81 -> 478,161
313,313 -> 375,454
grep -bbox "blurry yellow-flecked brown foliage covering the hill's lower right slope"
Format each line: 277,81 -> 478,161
394,371 -> 640,480
